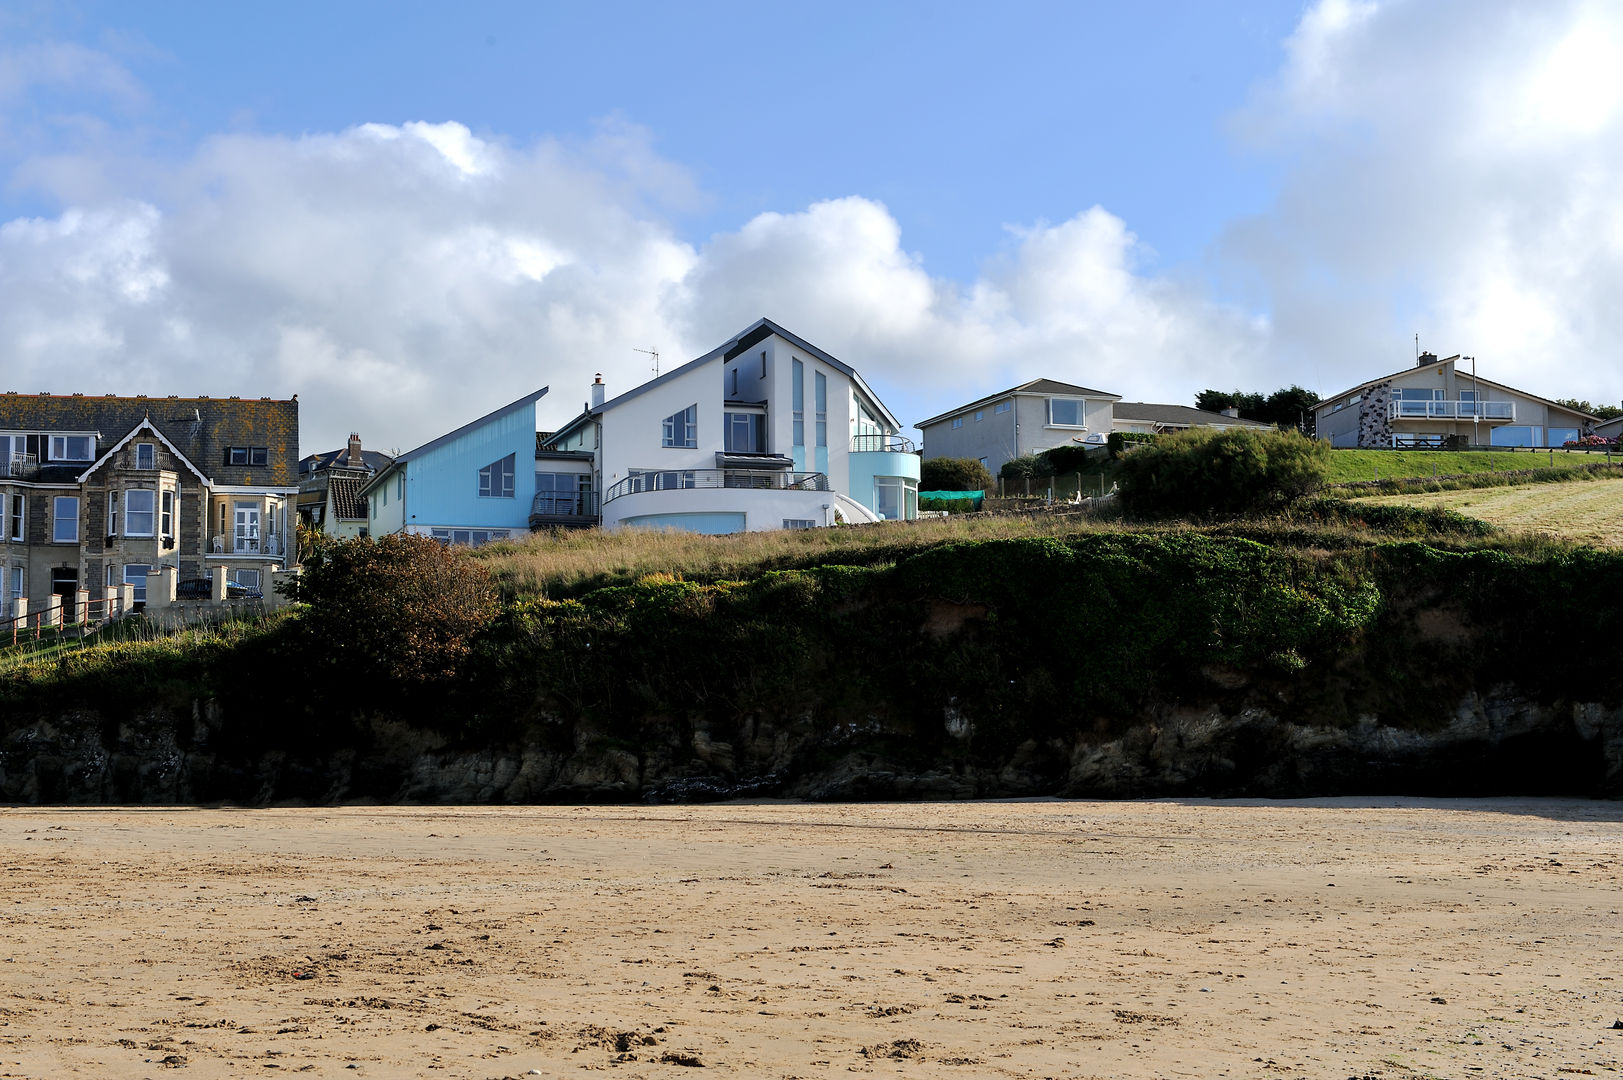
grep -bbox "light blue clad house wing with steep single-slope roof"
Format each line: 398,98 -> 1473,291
360,387 -> 547,547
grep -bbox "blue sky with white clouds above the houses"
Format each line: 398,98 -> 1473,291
0,0 -> 1623,453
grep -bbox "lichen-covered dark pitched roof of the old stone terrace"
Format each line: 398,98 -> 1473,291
0,391 -> 299,487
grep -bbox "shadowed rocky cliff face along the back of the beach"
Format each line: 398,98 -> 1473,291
0,690 -> 1623,804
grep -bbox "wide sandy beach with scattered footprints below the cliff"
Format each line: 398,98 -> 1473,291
0,799 -> 1623,1080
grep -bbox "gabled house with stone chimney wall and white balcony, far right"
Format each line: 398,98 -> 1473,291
1313,352 -> 1595,450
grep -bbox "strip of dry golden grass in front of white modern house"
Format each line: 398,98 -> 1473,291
476,513 -> 1120,598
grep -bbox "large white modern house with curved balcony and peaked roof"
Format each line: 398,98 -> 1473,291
531,318 -> 919,533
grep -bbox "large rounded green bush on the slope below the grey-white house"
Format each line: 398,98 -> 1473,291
1117,427 -> 1331,518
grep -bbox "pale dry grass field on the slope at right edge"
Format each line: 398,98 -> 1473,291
1360,477 -> 1623,547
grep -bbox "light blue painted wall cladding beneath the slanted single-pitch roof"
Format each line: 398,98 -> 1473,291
406,401 -> 536,529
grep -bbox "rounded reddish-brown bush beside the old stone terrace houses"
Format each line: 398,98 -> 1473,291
299,534 -> 497,682
